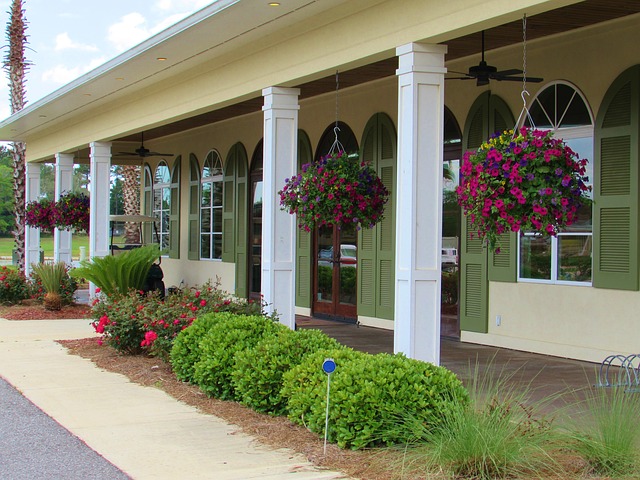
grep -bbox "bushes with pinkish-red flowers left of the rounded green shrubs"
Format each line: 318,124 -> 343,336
92,282 -> 276,360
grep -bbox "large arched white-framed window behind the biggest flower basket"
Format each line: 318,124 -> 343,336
518,82 -> 593,285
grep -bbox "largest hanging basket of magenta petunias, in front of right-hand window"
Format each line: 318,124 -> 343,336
456,127 -> 591,252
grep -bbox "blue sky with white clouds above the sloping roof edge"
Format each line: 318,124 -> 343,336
0,0 -> 213,120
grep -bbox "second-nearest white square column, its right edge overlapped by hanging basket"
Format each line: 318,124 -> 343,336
262,87 -> 300,329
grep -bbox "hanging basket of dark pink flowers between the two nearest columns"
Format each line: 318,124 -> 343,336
278,151 -> 389,232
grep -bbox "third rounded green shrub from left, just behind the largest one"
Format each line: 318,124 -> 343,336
232,329 -> 340,415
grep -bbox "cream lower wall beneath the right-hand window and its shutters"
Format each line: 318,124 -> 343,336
462,282 -> 640,362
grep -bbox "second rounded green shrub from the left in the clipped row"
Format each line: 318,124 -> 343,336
193,315 -> 286,400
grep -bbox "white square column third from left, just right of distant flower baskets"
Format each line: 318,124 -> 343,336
89,142 -> 111,270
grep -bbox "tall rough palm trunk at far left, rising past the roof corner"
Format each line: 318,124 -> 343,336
4,0 -> 30,270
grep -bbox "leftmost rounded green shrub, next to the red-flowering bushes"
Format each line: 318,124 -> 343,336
170,312 -> 234,382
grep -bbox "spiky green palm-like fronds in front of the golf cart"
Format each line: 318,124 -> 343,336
71,245 -> 160,296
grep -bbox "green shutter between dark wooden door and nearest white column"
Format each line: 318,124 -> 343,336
358,113 -> 397,320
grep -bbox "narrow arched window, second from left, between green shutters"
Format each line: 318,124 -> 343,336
200,150 -> 224,260
